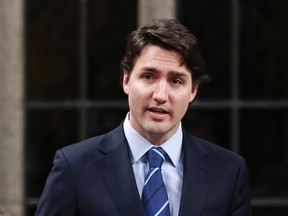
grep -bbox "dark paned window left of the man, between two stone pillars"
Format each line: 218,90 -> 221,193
25,0 -> 137,216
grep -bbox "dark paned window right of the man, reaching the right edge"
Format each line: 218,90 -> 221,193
178,0 -> 288,216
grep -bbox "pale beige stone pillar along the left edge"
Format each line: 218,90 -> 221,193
0,0 -> 24,216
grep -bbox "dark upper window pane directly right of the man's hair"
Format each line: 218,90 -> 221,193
178,0 -> 231,99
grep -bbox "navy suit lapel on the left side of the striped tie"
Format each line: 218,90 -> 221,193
96,126 -> 142,215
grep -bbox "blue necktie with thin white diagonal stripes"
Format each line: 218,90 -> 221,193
142,147 -> 170,216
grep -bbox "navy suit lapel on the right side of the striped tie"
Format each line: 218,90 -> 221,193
179,133 -> 209,216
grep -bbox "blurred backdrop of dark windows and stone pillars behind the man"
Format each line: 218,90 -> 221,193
0,0 -> 288,216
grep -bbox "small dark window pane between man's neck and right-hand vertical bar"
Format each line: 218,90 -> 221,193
183,109 -> 231,149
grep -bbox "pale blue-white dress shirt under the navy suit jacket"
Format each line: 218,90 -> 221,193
124,113 -> 183,216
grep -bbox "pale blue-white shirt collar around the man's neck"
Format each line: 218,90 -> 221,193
123,113 -> 183,167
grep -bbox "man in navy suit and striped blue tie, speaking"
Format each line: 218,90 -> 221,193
36,19 -> 250,216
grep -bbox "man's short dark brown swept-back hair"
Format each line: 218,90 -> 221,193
121,19 -> 210,83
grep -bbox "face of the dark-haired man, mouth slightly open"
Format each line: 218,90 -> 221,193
123,45 -> 198,145
